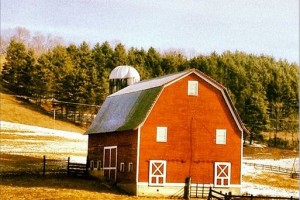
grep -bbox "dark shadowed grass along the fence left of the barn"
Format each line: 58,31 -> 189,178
0,154 -> 124,194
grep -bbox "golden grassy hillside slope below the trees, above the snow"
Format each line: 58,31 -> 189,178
0,88 -> 85,133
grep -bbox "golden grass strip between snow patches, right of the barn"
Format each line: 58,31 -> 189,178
243,172 -> 299,190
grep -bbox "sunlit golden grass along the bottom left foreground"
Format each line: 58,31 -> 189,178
0,176 -> 172,200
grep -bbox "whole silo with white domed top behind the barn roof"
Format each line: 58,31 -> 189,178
109,65 -> 141,94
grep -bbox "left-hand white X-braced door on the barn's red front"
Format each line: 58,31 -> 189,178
149,160 -> 167,186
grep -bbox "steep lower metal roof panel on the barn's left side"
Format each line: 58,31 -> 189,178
86,87 -> 162,134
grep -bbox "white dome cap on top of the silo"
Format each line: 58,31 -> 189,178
109,65 -> 141,81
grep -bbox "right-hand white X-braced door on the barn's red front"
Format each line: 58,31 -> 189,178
214,162 -> 231,187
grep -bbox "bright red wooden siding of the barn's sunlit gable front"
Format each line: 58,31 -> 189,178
139,74 -> 242,184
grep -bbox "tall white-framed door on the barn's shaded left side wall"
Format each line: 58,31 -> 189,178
103,146 -> 117,182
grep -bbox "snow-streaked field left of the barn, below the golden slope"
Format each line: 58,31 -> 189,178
0,121 -> 88,163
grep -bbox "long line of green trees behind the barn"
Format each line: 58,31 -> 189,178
2,28 -> 299,144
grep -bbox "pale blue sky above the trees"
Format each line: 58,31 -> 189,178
1,0 -> 299,63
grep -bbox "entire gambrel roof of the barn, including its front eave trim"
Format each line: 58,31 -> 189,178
85,69 -> 248,134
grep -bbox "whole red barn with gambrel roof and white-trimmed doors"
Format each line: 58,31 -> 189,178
86,69 -> 247,195
